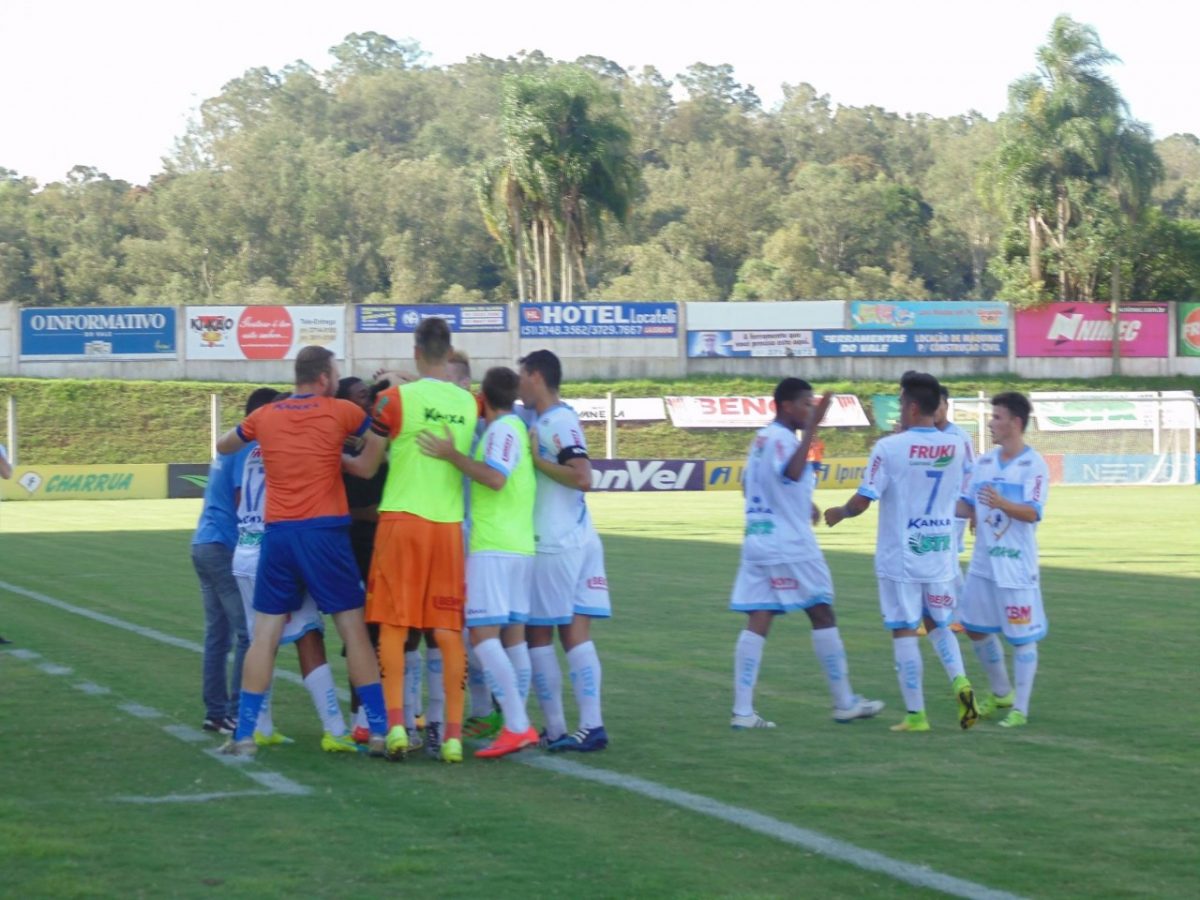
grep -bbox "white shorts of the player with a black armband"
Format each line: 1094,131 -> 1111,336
529,534 -> 612,625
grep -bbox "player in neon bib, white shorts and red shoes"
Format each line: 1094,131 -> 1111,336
416,367 -> 538,758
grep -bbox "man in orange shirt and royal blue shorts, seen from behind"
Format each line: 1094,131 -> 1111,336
217,347 -> 388,756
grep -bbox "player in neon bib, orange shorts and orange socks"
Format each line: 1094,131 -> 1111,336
343,318 -> 479,762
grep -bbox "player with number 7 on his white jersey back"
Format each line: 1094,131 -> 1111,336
826,372 -> 979,731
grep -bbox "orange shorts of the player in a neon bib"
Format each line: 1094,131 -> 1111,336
367,512 -> 467,631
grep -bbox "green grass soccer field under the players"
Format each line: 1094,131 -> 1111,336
0,487 -> 1200,898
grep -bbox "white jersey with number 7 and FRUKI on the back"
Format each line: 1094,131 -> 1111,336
858,427 -> 966,583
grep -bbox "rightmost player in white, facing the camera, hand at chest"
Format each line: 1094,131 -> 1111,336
959,391 -> 1050,728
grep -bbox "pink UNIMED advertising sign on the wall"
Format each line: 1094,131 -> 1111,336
1016,304 -> 1169,359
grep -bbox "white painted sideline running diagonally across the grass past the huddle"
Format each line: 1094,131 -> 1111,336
0,581 -> 1019,900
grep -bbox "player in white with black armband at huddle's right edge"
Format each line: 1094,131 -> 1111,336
520,350 -> 612,752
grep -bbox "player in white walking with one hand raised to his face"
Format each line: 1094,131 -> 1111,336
730,378 -> 883,731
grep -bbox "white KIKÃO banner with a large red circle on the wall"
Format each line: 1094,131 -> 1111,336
185,306 -> 346,361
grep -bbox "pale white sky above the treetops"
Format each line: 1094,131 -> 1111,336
0,0 -> 1200,184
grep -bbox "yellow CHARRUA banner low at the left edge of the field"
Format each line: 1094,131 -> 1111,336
0,463 -> 167,500
